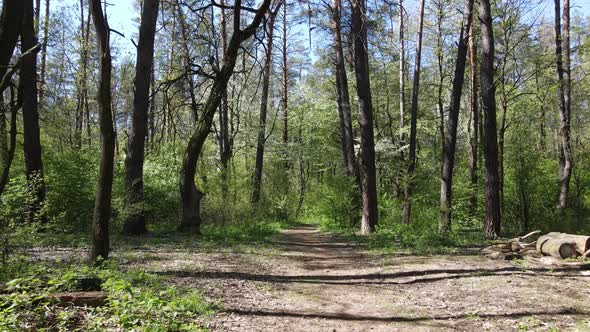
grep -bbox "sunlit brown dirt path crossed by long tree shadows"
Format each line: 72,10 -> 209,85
147,226 -> 590,331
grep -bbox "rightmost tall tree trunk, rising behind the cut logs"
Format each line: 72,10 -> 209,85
554,0 -> 573,209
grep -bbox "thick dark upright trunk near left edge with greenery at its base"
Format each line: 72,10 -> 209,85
20,0 -> 45,221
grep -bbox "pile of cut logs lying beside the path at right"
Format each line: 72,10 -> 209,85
481,231 -> 590,262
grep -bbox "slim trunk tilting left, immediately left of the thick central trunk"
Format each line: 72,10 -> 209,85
332,0 -> 358,177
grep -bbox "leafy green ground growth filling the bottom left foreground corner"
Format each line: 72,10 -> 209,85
0,260 -> 219,331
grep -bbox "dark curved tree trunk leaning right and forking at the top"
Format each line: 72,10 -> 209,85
179,0 -> 271,233
